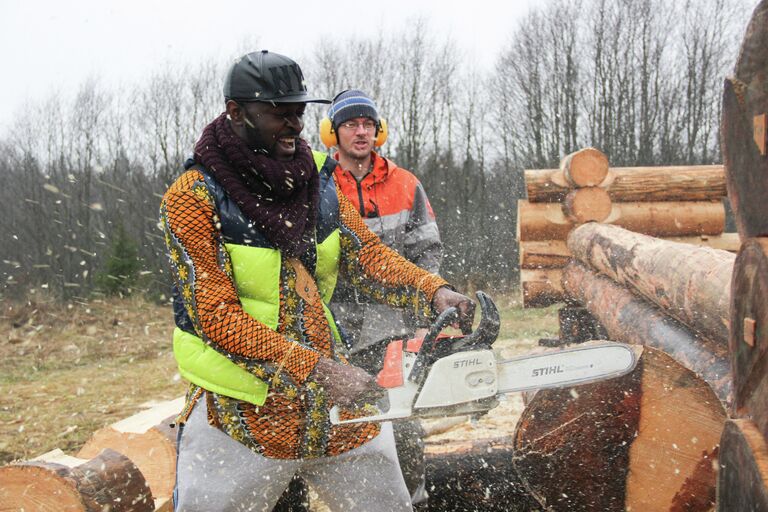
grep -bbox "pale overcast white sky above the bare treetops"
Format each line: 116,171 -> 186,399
0,0 -> 537,133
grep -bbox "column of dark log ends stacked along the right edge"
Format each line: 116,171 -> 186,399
717,0 -> 768,512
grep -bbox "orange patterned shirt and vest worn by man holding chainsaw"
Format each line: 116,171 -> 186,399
161,149 -> 447,459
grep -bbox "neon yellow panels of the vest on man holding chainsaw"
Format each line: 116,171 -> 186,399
173,151 -> 341,405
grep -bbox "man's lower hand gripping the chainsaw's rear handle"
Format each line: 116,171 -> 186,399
314,357 -> 386,407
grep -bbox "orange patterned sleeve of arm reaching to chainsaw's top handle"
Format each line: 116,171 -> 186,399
337,185 -> 448,319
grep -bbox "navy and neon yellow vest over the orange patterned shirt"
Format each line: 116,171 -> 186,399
173,151 -> 341,405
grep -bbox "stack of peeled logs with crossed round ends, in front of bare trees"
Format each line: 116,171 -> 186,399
517,148 -> 739,307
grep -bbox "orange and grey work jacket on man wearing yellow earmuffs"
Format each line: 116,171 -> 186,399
331,151 -> 443,353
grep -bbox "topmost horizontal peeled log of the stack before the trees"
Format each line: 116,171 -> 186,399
524,165 -> 727,203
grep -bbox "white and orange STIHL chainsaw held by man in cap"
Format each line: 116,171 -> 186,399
330,291 -> 637,425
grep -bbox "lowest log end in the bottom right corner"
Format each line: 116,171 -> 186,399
717,420 -> 768,512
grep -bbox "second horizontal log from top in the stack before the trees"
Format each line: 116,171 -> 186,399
517,200 -> 725,242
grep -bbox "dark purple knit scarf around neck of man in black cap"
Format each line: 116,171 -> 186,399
195,114 -> 320,256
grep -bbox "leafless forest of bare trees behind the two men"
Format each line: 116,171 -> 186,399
0,0 -> 753,300
